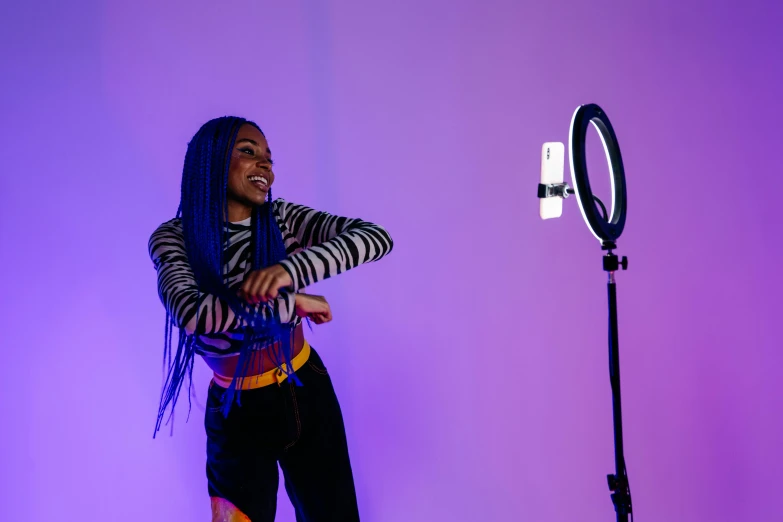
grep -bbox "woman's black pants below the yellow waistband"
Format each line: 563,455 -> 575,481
204,349 -> 359,522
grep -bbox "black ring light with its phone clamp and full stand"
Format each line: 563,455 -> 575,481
538,104 -> 633,522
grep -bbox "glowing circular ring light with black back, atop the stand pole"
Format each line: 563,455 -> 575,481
568,103 -> 628,243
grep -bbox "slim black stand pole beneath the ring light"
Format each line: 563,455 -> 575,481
603,241 -> 632,522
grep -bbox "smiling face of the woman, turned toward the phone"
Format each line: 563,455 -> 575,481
227,124 -> 275,214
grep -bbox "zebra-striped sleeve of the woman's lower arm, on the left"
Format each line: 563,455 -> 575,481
149,218 -> 296,335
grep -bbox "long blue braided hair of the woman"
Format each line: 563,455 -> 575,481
153,116 -> 299,438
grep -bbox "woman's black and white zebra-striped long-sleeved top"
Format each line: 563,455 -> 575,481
149,199 -> 393,357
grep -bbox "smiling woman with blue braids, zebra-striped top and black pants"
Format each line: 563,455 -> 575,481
149,117 -> 392,522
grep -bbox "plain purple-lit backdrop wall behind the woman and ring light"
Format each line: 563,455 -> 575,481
0,0 -> 783,522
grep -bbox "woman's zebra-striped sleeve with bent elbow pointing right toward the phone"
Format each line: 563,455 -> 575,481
276,200 -> 394,292
